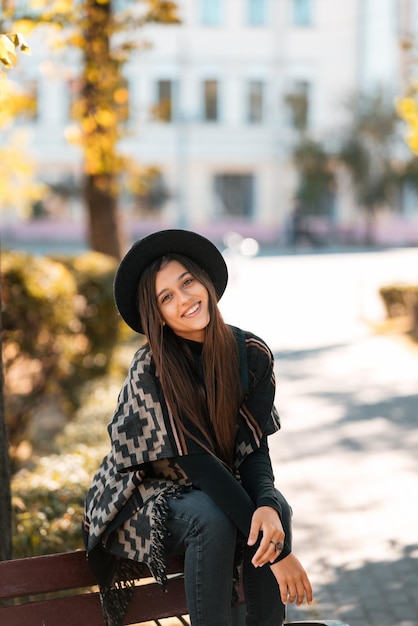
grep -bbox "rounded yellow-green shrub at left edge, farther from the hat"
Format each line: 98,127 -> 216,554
2,252 -> 77,441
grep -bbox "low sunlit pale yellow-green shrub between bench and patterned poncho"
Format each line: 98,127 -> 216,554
12,376 -> 122,558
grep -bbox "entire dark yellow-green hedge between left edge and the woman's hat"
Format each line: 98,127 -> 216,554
2,247 -> 126,445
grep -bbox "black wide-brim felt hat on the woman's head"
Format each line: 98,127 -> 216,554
113,229 -> 228,334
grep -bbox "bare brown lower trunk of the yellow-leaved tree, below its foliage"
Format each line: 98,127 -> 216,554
85,175 -> 123,259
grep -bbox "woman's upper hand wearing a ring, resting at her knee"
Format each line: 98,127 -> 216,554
247,506 -> 284,567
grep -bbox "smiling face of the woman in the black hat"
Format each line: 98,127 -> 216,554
155,260 -> 210,342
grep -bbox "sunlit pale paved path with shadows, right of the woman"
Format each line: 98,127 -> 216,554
221,250 -> 418,626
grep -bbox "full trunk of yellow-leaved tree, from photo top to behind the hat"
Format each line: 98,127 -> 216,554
82,0 -> 122,259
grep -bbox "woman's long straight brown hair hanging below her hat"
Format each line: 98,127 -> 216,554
138,254 -> 240,466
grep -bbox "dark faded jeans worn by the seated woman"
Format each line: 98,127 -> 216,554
166,489 -> 291,626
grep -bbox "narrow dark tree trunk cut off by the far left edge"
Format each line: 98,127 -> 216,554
0,286 -> 12,561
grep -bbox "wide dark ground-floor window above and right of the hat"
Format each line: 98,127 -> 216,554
214,174 -> 254,217
